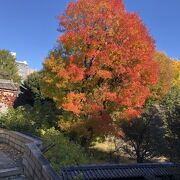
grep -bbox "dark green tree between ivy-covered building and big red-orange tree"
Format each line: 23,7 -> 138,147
15,71 -> 62,129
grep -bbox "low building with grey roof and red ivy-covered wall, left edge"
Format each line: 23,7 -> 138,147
0,79 -> 18,112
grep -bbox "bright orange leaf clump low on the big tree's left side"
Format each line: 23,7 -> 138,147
62,92 -> 86,115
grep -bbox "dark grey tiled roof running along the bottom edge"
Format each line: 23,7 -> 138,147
61,163 -> 180,180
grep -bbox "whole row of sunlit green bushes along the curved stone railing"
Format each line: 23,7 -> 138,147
0,106 -> 92,171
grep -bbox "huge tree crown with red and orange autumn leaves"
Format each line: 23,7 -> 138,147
44,0 -> 158,139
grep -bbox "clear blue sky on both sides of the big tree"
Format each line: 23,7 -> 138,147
0,0 -> 180,69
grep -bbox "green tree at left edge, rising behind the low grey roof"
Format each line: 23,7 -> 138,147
0,49 -> 21,83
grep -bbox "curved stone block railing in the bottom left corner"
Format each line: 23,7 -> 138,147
0,129 -> 61,180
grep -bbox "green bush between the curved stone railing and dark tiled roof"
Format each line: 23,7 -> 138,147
41,128 -> 92,171
